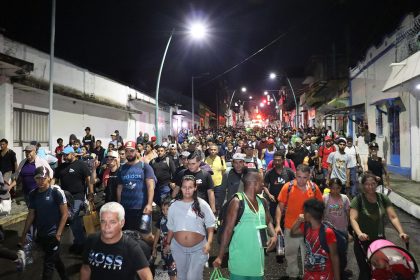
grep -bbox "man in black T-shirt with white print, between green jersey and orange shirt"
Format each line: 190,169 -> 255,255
264,151 -> 295,221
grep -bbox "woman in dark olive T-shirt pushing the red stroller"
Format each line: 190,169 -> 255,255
350,172 -> 409,280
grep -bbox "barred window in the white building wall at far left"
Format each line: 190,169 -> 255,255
13,108 -> 48,146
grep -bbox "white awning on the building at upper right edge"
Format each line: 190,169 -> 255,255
382,51 -> 420,91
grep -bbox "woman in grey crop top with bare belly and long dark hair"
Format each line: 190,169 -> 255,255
164,175 -> 216,280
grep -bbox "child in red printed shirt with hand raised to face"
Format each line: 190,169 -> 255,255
291,199 -> 340,280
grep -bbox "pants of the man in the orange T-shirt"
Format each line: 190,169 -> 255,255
284,229 -> 305,277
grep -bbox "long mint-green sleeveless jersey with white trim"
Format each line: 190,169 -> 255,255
229,193 -> 266,276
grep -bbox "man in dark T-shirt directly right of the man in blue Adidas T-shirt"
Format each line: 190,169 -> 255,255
150,146 -> 176,205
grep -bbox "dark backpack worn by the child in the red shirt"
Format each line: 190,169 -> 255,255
303,222 -> 348,279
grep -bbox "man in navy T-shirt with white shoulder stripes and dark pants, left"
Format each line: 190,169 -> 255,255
21,166 -> 69,280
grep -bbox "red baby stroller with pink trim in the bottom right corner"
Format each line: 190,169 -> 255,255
366,239 -> 419,280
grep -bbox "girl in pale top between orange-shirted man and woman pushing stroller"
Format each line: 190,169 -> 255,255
323,178 -> 350,236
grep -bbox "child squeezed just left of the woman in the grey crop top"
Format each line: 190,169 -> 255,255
152,200 -> 176,280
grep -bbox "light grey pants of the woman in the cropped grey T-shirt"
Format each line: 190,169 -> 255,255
171,238 -> 209,280
